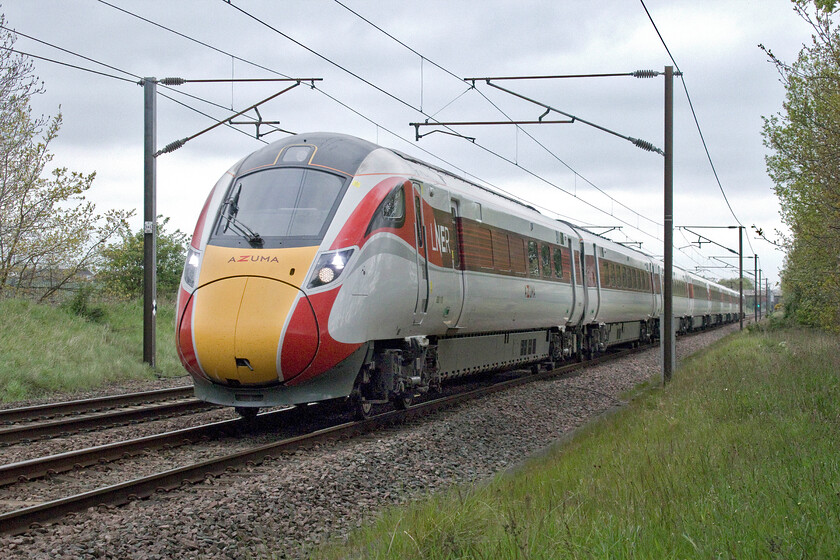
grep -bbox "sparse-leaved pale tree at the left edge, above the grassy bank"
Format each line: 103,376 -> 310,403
0,14 -> 131,300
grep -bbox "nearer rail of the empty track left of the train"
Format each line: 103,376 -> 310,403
0,398 -> 218,445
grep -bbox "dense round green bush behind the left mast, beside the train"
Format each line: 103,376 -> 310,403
97,216 -> 188,298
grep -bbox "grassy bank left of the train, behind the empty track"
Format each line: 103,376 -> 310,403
0,299 -> 184,402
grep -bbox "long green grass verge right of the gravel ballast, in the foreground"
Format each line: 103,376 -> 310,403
317,328 -> 840,559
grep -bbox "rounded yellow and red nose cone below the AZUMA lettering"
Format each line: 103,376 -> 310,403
193,277 -> 318,386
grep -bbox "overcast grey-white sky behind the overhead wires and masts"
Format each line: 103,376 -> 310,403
2,0 -> 810,284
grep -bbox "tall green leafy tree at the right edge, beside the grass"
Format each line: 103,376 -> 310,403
760,0 -> 840,331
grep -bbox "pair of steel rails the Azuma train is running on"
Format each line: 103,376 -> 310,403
0,347 -> 647,535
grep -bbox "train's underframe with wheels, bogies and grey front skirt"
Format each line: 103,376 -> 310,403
220,314 -> 737,419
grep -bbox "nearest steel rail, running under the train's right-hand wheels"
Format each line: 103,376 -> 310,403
0,347 -> 632,535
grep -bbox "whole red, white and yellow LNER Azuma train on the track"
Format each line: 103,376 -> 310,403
175,132 -> 739,418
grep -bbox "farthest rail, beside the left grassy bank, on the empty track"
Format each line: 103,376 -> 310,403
0,385 -> 193,424
